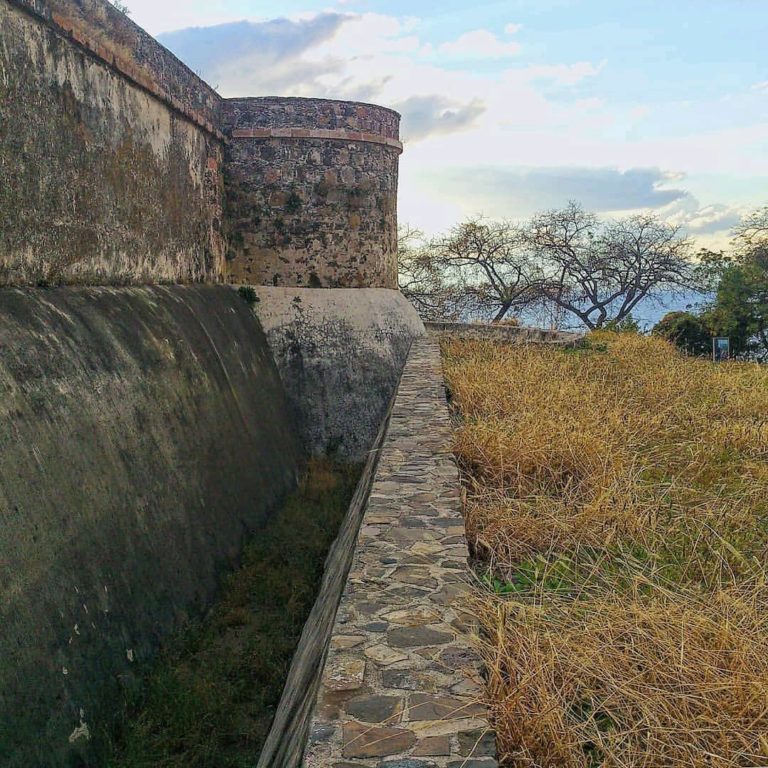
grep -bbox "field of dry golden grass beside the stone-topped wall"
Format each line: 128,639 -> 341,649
443,334 -> 768,768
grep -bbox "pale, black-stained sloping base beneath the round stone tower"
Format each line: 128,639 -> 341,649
256,287 -> 424,460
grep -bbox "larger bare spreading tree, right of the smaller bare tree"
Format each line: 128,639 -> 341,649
526,203 -> 694,329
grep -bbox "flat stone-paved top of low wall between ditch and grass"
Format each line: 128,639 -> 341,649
304,337 -> 497,768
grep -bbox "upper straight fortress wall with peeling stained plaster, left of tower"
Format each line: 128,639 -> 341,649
0,0 -> 225,286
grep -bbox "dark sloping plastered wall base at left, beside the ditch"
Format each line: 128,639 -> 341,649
0,286 -> 301,768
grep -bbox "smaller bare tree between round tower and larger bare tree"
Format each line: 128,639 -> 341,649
433,218 -> 536,323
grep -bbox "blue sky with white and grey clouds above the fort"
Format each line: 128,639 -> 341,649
128,0 -> 768,246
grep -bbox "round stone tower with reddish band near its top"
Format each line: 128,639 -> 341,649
224,98 -> 403,288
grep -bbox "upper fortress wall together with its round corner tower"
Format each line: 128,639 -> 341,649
0,0 -> 402,289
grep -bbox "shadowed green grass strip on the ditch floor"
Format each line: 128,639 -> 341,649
107,461 -> 360,768
